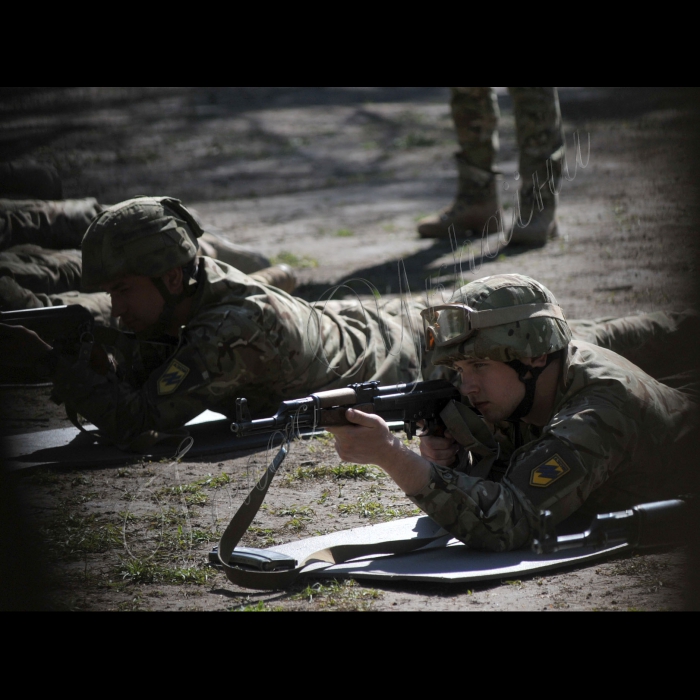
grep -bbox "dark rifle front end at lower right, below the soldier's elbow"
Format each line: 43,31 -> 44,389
532,499 -> 689,554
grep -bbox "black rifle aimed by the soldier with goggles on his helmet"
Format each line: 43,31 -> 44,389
231,380 -> 461,440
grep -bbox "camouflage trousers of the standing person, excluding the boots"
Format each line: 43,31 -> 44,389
450,87 -> 564,201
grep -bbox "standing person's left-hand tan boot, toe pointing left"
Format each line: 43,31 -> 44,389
418,154 -> 501,238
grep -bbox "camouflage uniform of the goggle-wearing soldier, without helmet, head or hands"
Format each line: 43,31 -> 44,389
411,314 -> 699,551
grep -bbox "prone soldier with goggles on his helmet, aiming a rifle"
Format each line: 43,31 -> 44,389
331,275 -> 698,551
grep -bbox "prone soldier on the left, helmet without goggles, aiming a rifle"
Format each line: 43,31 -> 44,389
0,198 -> 422,450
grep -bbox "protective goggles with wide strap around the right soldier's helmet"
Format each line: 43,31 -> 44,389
421,304 -> 566,352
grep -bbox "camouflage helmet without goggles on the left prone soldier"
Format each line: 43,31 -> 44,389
82,197 -> 204,292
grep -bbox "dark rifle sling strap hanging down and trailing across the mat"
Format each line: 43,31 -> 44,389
219,444 -> 445,590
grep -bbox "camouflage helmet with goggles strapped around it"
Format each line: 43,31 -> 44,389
423,275 -> 571,366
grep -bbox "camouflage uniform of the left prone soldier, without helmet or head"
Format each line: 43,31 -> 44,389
53,258 -> 422,448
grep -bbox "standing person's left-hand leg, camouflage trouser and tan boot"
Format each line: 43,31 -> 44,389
418,87 -> 500,238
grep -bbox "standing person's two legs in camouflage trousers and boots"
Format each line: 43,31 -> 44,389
418,87 -> 564,247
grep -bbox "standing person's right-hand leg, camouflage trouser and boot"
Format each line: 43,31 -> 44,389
508,87 -> 565,246
